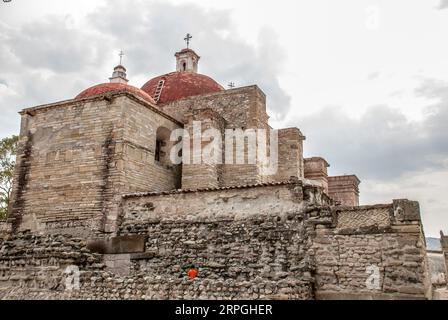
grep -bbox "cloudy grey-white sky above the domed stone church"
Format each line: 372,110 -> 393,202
0,0 -> 448,236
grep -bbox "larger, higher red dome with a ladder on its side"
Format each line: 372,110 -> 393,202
142,72 -> 224,103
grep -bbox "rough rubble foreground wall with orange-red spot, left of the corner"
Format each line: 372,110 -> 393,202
0,183 -> 313,299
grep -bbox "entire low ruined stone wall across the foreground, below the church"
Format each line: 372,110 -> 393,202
0,181 -> 429,299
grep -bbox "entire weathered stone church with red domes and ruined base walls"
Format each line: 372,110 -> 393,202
0,46 -> 431,299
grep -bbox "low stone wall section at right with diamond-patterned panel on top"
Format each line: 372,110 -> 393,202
313,200 -> 431,299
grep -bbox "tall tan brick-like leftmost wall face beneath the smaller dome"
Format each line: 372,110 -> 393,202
10,100 -> 121,232
